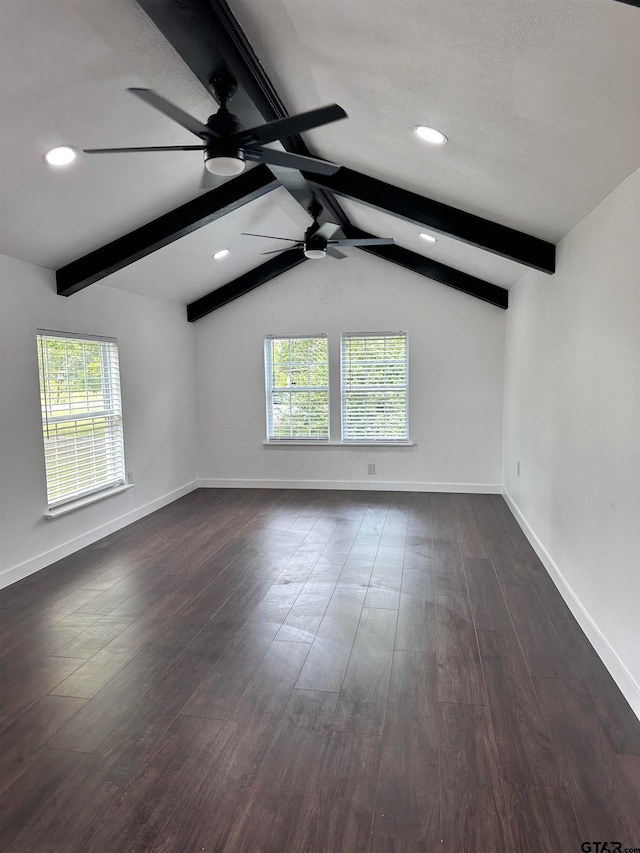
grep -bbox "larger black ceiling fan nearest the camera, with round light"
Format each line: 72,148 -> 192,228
83,73 -> 347,177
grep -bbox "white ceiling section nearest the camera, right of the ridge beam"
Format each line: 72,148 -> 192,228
232,0 -> 640,242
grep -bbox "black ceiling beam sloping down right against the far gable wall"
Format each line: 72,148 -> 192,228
343,226 -> 509,308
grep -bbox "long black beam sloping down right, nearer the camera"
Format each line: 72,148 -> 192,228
304,166 -> 556,273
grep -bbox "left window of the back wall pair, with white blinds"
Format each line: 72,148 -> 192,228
264,335 -> 329,441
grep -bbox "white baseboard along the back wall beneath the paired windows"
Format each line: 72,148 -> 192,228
198,479 -> 502,495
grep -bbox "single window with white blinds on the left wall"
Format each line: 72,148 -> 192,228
38,329 -> 125,509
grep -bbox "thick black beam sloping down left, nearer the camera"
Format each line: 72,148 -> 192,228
56,165 -> 280,296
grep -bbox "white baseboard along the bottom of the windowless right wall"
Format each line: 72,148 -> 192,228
502,488 -> 640,719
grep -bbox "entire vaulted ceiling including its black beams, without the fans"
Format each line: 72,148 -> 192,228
0,0 -> 640,319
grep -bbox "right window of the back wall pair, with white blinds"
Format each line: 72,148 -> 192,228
341,332 -> 409,442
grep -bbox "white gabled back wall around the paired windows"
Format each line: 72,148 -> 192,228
195,249 -> 505,491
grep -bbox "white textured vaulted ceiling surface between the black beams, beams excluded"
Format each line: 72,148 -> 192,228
0,0 -> 640,303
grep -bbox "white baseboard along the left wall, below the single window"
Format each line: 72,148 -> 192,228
0,480 -> 198,589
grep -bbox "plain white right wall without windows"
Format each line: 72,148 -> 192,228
504,172 -> 640,715
